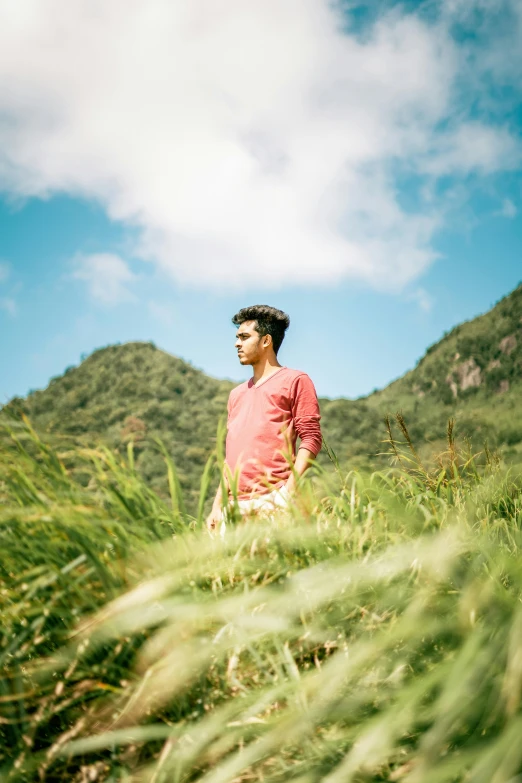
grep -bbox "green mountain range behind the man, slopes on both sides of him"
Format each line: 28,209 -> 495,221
6,285 -> 522,500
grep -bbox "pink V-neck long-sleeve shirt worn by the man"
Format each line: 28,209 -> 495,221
226,367 -> 322,498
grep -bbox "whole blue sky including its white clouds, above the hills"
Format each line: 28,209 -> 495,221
0,0 -> 522,401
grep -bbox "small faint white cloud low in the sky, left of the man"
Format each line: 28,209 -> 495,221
72,253 -> 137,305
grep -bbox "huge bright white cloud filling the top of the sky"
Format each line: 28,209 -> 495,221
0,0 -> 520,290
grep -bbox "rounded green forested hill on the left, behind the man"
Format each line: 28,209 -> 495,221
5,343 -> 234,505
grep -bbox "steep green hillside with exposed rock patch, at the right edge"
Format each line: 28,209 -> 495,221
367,285 -> 522,462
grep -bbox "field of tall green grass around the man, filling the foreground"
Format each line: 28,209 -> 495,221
0,417 -> 522,783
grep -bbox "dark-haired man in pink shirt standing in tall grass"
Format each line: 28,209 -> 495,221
207,305 -> 322,530
